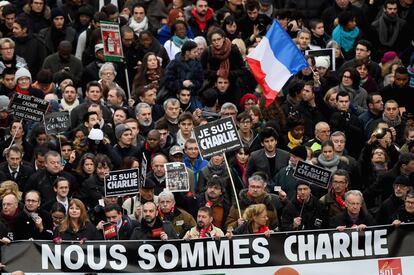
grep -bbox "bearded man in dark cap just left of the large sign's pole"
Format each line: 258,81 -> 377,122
197,176 -> 231,230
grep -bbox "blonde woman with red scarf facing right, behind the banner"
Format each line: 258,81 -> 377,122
233,203 -> 272,237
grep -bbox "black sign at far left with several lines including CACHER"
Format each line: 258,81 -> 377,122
10,93 -> 49,122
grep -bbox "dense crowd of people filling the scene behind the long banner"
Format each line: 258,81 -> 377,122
0,0 -> 414,260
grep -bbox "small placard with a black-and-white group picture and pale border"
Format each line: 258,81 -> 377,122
164,162 -> 190,192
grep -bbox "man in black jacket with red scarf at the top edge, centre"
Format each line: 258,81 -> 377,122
188,0 -> 216,37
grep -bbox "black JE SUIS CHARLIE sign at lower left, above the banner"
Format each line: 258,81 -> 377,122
105,169 -> 139,197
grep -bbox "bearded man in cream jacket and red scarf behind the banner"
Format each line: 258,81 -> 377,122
183,206 -> 224,241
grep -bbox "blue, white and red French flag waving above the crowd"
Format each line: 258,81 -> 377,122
247,20 -> 309,107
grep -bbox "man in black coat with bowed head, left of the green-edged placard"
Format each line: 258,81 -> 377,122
42,40 -> 83,84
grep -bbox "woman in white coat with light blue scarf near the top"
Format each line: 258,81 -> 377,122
164,20 -> 189,60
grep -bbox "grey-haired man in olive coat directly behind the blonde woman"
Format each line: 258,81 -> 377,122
225,176 -> 282,231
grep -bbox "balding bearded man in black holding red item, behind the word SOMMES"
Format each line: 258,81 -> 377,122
131,201 -> 178,241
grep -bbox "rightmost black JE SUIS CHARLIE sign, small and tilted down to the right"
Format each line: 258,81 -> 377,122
293,160 -> 332,188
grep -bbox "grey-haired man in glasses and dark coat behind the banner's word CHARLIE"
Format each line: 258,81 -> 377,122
329,190 -> 375,231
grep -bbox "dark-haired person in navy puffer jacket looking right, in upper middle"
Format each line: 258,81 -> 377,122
164,41 -> 203,97
